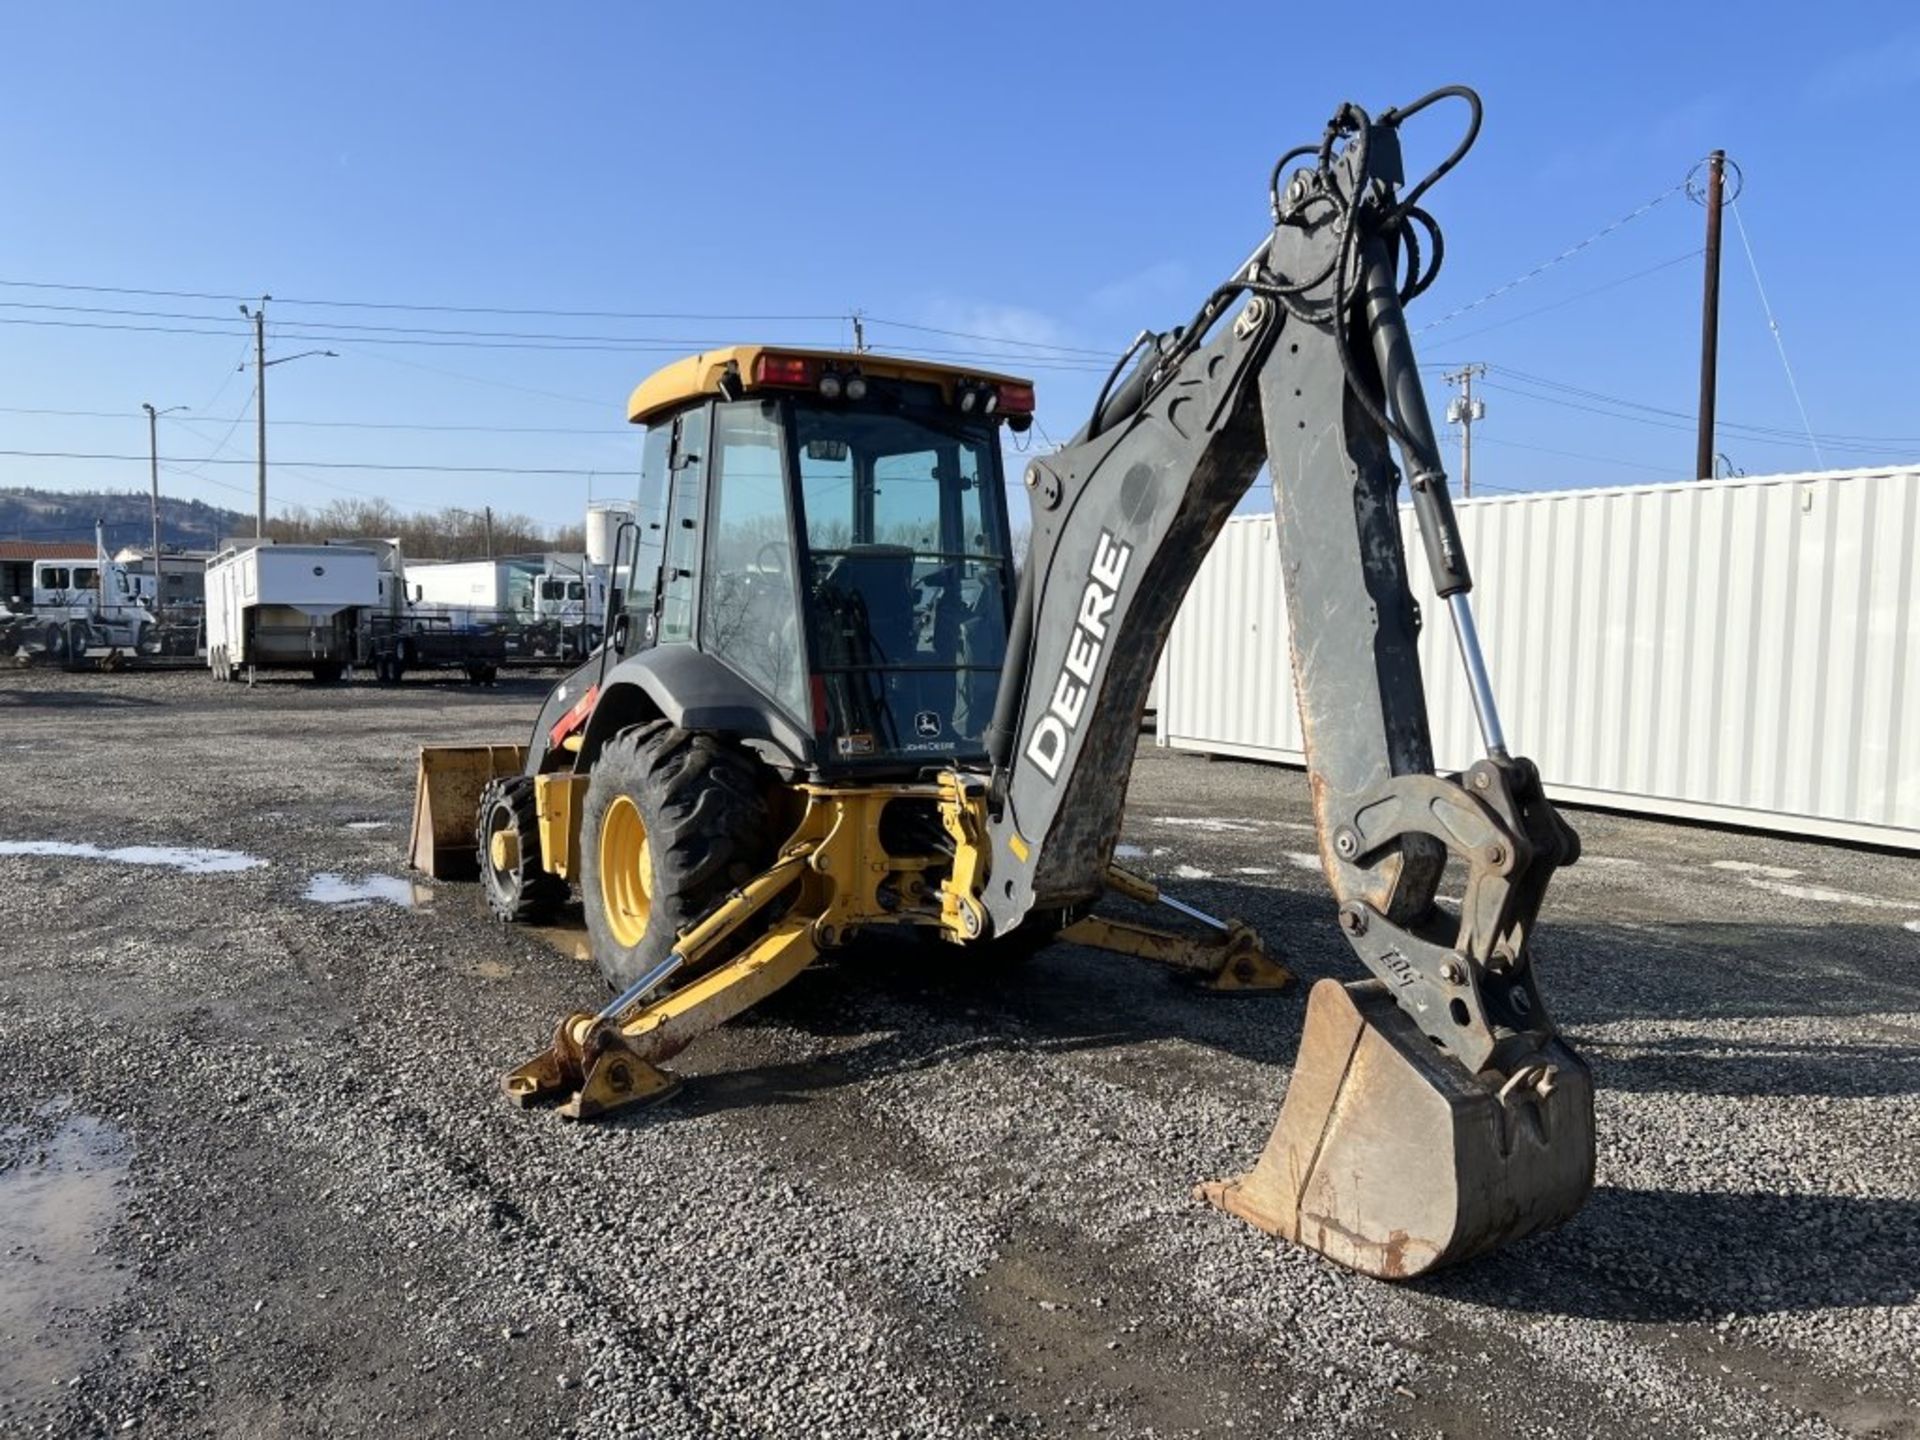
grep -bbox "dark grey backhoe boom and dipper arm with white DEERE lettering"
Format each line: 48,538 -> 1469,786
981,88 -> 1576,1071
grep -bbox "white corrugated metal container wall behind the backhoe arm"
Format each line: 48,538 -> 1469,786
1160,468 -> 1920,849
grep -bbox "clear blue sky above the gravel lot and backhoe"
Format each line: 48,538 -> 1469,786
0,4 -> 1920,537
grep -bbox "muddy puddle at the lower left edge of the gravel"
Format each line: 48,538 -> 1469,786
0,1102 -> 132,1404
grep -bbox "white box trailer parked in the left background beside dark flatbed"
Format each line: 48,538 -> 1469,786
207,545 -> 380,682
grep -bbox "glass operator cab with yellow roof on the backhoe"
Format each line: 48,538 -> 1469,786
616,346 -> 1033,774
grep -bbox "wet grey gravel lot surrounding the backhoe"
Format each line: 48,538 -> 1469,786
0,672 -> 1920,1438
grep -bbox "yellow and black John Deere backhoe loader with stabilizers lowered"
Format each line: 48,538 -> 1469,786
415,86 -> 1594,1277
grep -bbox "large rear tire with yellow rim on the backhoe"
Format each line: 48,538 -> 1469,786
580,720 -> 776,991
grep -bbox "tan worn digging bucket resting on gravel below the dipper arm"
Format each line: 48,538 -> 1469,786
1198,979 -> 1594,1279
